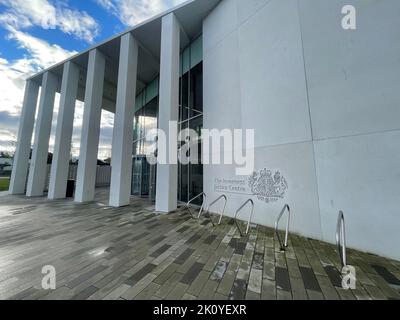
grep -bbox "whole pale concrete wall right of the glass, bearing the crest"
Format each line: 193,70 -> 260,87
203,0 -> 400,259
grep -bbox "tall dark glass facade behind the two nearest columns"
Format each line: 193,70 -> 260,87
132,37 -> 203,202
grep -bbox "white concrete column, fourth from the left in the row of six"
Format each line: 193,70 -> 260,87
75,49 -> 106,202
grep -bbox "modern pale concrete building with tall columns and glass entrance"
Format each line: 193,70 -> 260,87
10,0 -> 400,259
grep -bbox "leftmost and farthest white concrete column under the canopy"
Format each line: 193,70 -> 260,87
9,80 -> 39,195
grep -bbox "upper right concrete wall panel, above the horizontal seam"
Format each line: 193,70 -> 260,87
299,0 -> 400,139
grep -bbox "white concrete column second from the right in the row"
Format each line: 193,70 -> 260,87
110,33 -> 138,207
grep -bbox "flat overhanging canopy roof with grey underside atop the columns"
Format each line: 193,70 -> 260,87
28,0 -> 221,90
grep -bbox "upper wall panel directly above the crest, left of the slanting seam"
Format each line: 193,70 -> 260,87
239,0 -> 311,147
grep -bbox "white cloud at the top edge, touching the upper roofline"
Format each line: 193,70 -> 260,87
95,0 -> 185,26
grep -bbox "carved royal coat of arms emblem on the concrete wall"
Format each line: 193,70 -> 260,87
249,169 -> 289,203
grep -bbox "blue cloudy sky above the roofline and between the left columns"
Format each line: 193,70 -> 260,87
0,0 -> 184,159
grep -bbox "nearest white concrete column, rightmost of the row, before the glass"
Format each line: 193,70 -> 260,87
156,13 -> 180,213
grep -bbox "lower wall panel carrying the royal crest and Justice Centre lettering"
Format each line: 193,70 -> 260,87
204,142 -> 322,239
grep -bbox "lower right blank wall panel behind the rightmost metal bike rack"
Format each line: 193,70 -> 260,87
315,131 -> 400,259
